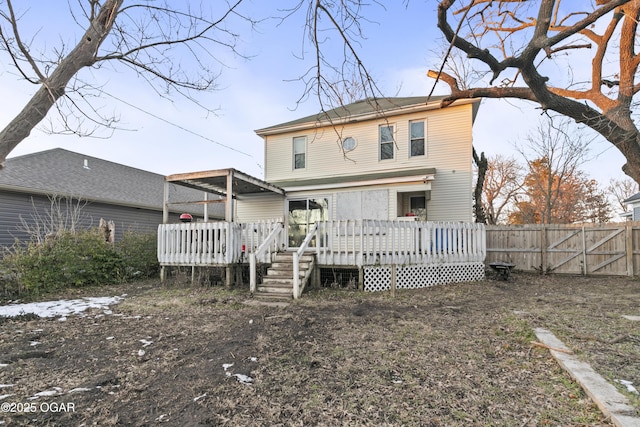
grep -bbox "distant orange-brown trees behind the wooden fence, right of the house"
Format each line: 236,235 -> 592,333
475,118 -> 638,224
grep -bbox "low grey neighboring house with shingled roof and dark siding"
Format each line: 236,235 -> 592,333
0,148 -> 222,246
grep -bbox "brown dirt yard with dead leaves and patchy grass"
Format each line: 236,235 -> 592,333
0,274 -> 640,427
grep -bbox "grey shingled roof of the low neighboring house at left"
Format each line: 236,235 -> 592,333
0,148 -> 214,214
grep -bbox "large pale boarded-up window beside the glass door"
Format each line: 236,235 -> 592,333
336,190 -> 389,220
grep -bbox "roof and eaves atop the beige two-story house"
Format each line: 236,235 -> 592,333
255,96 -> 480,136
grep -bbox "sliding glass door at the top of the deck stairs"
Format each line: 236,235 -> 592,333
287,198 -> 329,248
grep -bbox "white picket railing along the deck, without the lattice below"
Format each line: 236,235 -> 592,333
158,220 -> 486,266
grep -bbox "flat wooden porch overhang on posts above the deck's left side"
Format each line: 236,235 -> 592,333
164,168 -> 285,222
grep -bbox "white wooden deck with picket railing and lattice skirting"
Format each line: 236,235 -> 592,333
158,220 -> 486,290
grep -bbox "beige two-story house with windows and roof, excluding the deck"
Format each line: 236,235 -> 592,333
237,97 -> 479,239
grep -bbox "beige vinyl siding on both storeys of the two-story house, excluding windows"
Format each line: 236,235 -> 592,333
265,104 -> 473,221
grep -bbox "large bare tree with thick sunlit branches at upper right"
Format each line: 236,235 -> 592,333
428,0 -> 640,186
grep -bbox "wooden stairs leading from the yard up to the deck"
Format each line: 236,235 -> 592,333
253,252 -> 315,302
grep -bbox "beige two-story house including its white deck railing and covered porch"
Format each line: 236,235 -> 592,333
159,97 -> 484,296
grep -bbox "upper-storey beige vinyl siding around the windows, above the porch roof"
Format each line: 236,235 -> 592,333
265,105 -> 472,182
